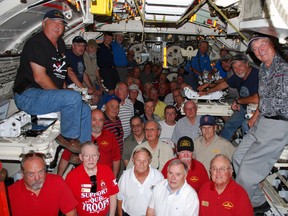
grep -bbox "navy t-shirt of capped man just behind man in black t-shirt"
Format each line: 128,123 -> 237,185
65,50 -> 86,85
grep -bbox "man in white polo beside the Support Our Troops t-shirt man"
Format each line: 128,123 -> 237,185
117,148 -> 163,216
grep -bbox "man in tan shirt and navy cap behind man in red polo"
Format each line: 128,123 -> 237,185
194,115 -> 235,173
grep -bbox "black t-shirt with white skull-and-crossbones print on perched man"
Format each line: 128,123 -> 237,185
14,31 -> 67,92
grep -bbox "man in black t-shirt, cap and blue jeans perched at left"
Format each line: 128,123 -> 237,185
13,10 -> 91,153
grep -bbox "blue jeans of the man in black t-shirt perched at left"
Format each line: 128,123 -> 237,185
14,88 -> 92,143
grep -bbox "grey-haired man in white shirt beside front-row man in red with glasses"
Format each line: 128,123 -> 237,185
146,160 -> 199,216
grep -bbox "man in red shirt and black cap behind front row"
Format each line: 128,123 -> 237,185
162,136 -> 209,193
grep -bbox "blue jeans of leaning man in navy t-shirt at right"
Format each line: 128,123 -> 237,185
220,106 -> 246,141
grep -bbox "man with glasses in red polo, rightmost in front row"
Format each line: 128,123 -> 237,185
198,154 -> 253,216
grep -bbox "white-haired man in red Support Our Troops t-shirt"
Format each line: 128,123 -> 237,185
66,142 -> 119,216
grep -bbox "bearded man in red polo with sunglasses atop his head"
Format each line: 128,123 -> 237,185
8,152 -> 78,216
